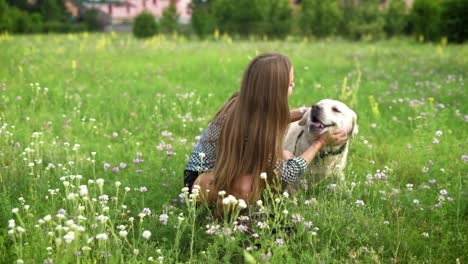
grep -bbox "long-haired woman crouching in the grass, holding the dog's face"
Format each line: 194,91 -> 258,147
184,53 -> 346,203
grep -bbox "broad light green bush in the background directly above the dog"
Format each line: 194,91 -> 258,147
299,0 -> 341,37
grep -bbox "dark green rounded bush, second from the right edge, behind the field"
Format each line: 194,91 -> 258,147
410,0 -> 441,40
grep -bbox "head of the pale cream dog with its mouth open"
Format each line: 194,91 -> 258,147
299,99 -> 358,138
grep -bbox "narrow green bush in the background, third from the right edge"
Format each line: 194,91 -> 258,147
384,0 -> 408,37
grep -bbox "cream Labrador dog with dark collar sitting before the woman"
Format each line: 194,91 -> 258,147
283,99 -> 358,190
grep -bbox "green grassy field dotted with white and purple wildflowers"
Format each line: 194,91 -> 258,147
0,33 -> 468,263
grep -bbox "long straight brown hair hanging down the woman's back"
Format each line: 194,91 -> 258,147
214,53 -> 292,201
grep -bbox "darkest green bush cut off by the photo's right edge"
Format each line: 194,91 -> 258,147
441,0 -> 468,42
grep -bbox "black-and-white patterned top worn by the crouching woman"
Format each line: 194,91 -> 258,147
185,116 -> 307,187
